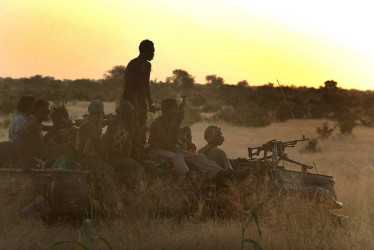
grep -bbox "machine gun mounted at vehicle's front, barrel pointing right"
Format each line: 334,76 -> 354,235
248,135 -> 313,173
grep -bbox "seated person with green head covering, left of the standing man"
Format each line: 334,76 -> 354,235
53,100 -> 141,175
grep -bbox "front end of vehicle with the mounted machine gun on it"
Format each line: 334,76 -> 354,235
226,136 -> 345,217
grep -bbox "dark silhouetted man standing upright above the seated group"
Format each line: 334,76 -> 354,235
123,40 -> 157,145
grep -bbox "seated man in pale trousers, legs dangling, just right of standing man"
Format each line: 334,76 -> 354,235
149,98 -> 222,183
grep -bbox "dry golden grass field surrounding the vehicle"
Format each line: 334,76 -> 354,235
0,102 -> 374,249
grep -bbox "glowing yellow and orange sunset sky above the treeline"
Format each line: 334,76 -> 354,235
0,0 -> 374,90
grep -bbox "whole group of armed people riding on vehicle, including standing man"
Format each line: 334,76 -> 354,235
0,40 -> 248,186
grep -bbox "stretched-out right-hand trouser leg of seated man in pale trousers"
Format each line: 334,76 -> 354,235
178,151 -> 222,179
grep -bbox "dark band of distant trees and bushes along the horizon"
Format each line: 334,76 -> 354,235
0,66 -> 374,132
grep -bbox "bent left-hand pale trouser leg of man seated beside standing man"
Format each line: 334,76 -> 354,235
150,149 -> 190,183
